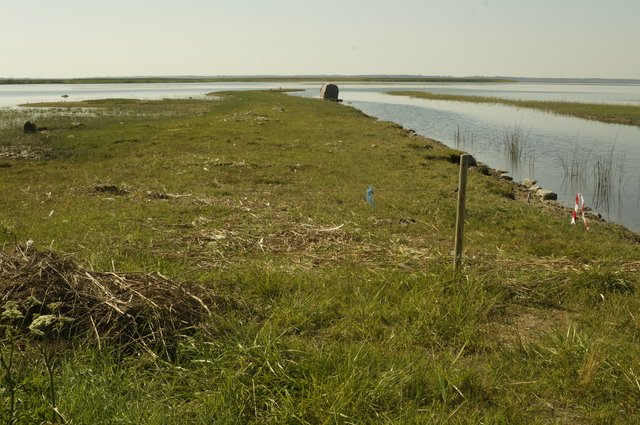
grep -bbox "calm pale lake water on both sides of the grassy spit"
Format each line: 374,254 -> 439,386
0,81 -> 640,232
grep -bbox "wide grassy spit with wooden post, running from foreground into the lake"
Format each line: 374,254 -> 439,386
0,92 -> 640,424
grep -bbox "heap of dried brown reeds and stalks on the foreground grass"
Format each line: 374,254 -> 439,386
0,246 -> 213,354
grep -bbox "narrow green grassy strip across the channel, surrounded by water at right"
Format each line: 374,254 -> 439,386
388,91 -> 640,126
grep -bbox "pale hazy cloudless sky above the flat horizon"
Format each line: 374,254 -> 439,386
0,0 -> 640,78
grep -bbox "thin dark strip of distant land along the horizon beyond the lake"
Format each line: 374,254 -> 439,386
0,75 -> 515,84
